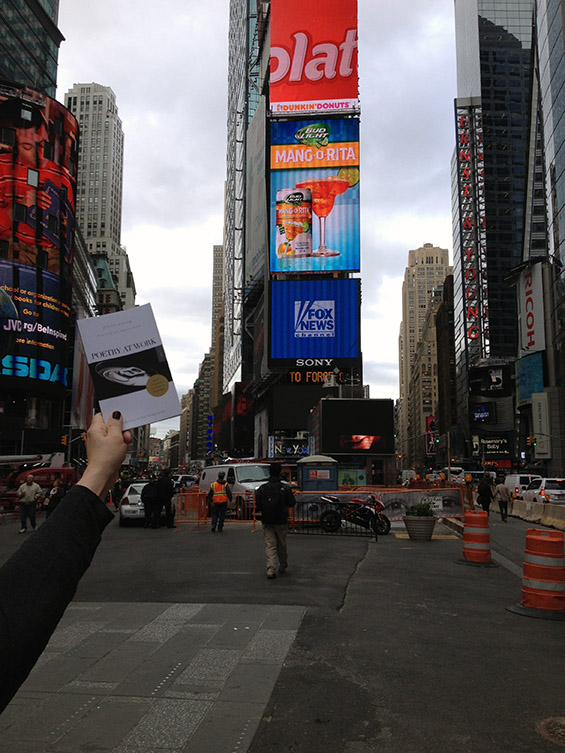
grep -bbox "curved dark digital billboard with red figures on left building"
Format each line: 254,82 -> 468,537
0,85 -> 78,389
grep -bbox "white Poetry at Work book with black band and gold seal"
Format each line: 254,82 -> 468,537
77,303 -> 181,429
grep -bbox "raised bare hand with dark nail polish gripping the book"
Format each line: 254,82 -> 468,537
78,411 -> 132,500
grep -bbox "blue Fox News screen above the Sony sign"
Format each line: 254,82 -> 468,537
269,280 -> 360,361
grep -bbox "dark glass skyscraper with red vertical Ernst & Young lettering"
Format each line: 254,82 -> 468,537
452,0 -> 543,463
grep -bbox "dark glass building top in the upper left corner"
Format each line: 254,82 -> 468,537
0,0 -> 64,97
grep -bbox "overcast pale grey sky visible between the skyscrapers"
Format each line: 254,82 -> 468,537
57,0 -> 456,436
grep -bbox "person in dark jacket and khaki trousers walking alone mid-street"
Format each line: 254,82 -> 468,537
255,463 -> 296,579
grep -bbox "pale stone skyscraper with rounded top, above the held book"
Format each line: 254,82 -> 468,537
65,83 -> 135,308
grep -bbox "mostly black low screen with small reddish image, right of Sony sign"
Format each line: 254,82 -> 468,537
320,399 -> 394,455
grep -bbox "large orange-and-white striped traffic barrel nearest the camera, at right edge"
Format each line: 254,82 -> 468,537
508,528 -> 565,620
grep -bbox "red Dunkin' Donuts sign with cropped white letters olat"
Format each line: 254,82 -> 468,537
270,0 -> 359,115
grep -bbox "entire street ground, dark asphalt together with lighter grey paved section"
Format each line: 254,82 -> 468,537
0,508 -> 565,753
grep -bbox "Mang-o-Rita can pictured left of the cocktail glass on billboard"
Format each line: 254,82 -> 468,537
276,188 -> 312,258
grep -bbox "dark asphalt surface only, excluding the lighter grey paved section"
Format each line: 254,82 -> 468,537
0,506 -> 565,753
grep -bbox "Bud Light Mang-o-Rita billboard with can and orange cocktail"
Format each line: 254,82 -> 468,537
269,118 -> 360,273
